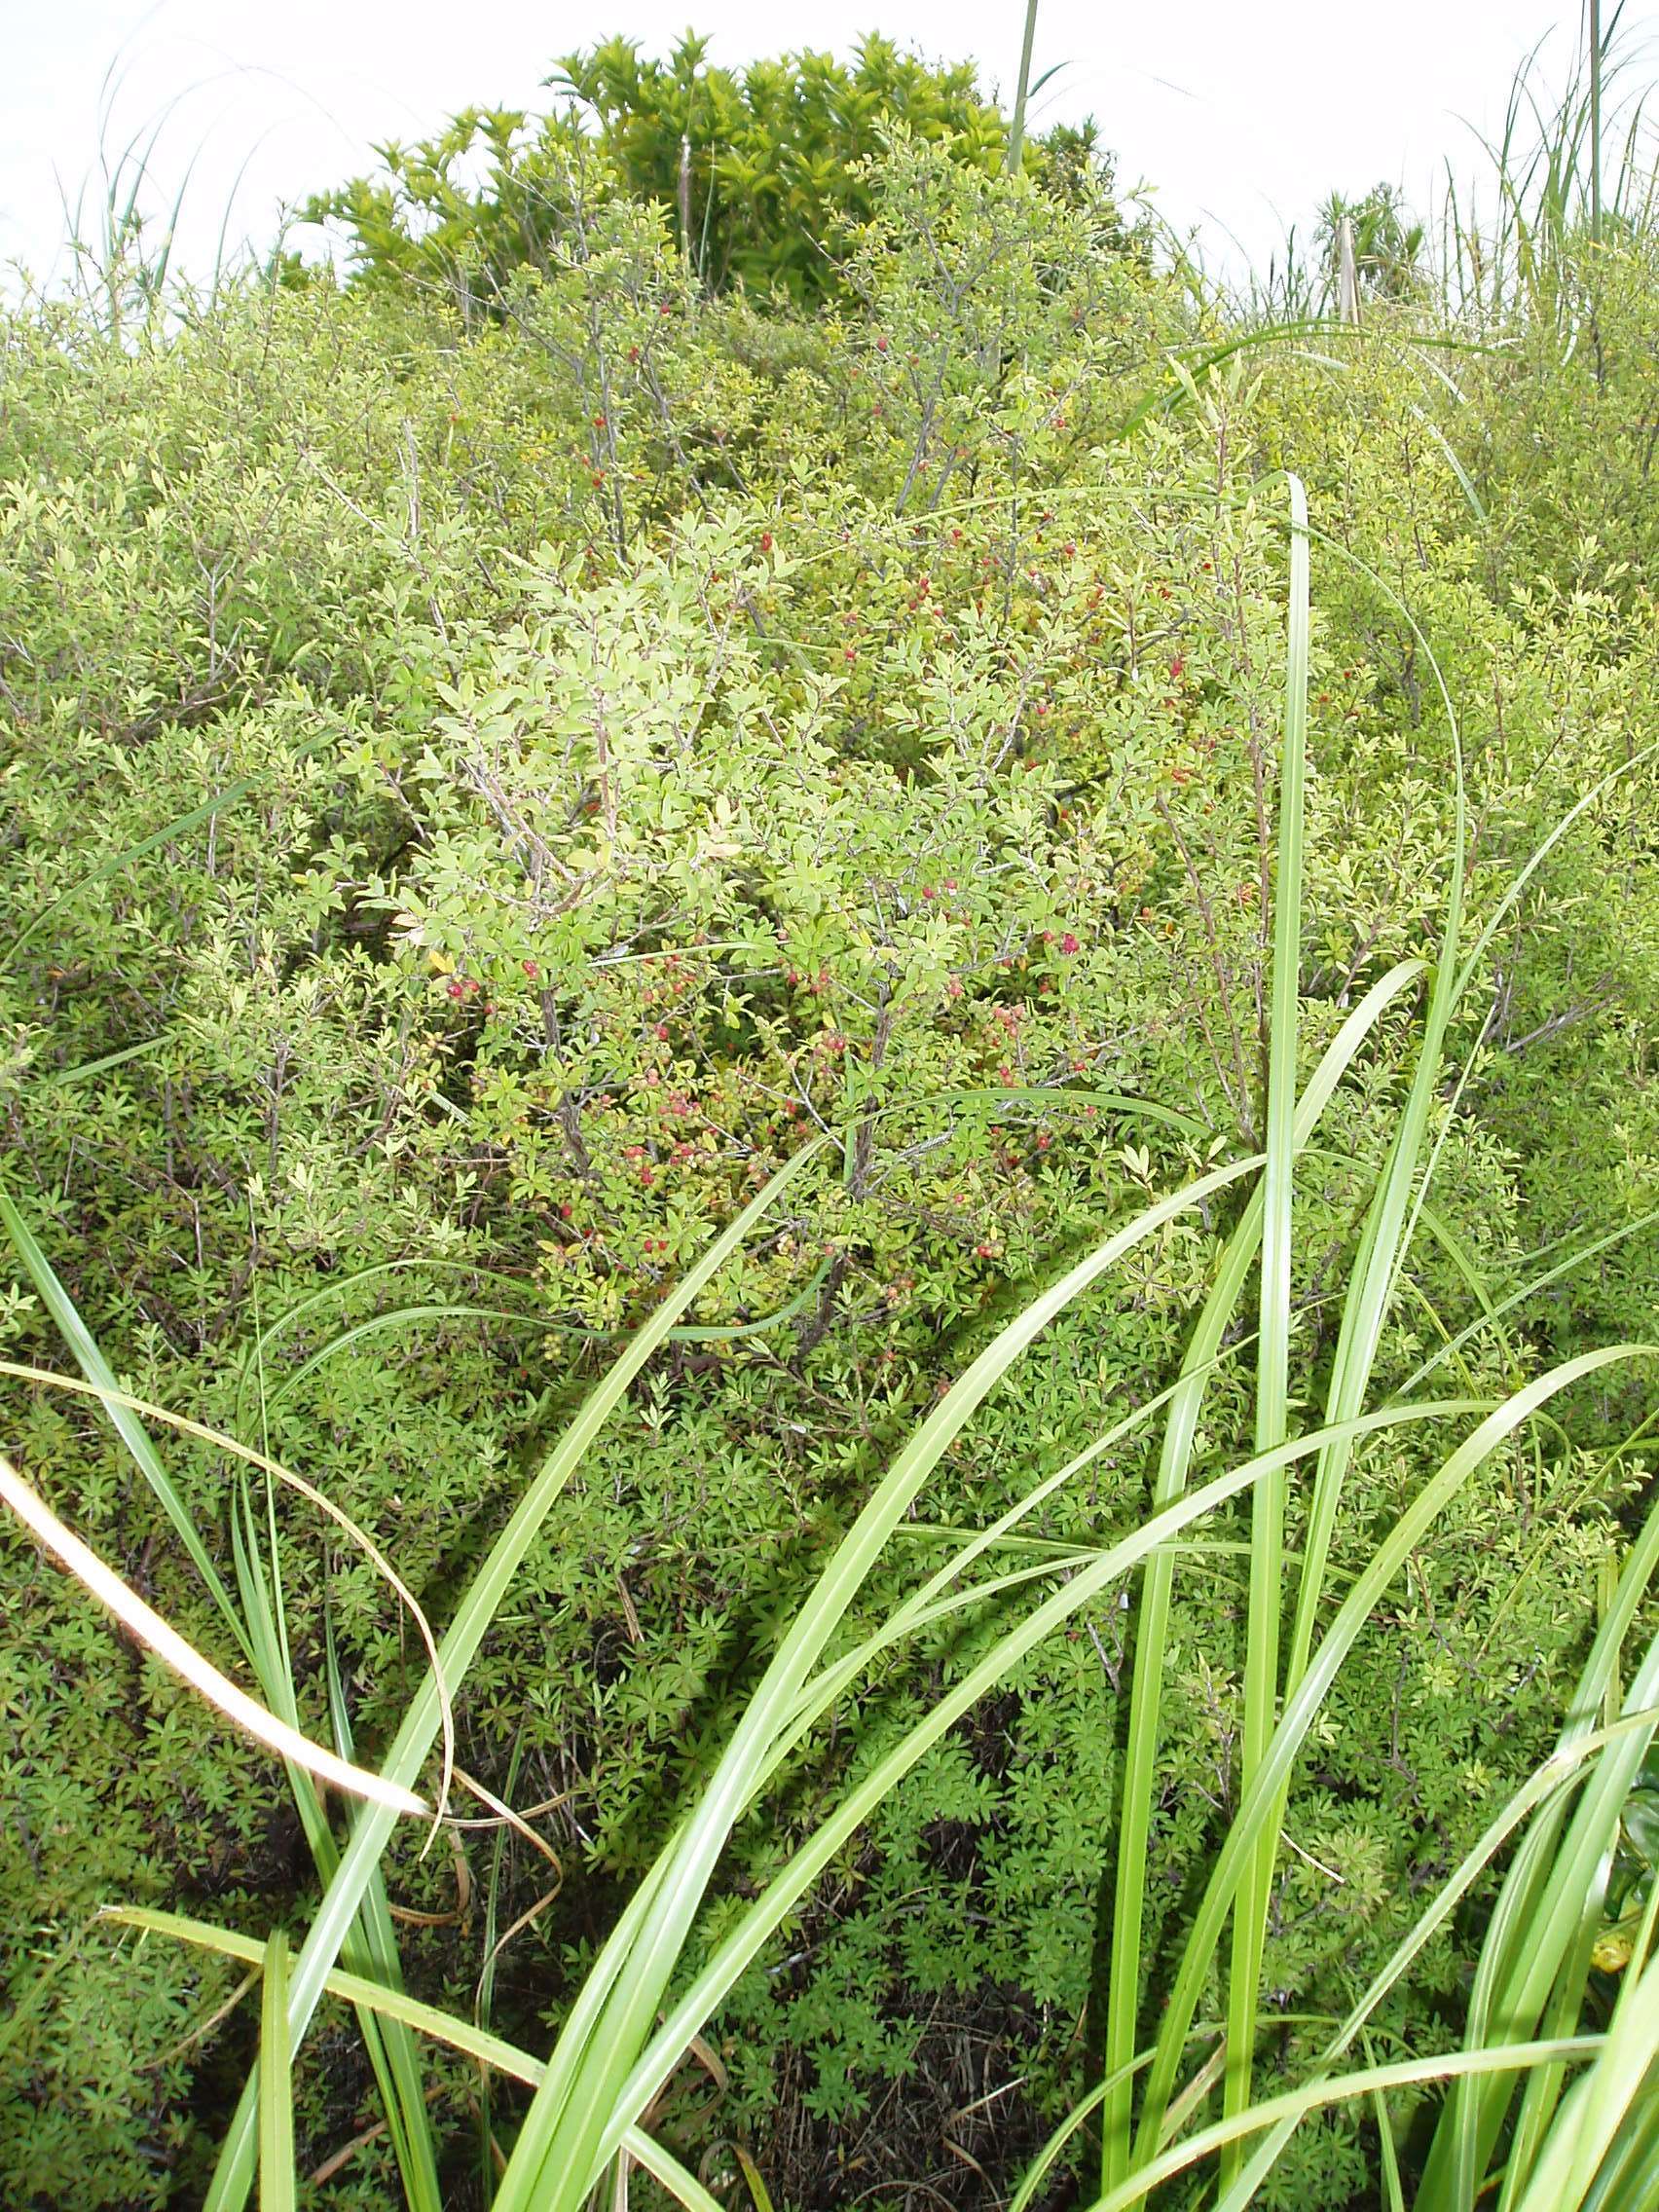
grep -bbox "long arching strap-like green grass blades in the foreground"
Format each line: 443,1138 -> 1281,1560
61,480 -> 1659,2212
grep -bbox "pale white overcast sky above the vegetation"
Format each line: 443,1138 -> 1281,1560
0,0 -> 1659,291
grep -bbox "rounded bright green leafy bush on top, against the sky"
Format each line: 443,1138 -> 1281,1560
303,33 -> 1128,316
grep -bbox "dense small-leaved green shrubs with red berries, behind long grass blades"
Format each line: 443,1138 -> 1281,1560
0,54 -> 1659,2207
